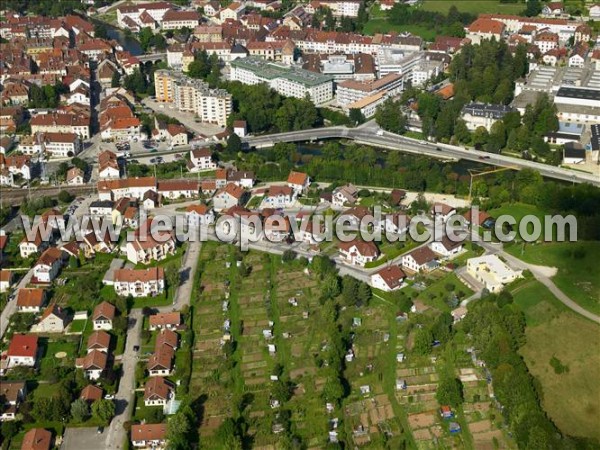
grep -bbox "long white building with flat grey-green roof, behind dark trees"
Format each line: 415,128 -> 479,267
231,58 -> 333,105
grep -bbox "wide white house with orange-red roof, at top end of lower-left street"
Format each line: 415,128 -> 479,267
113,267 -> 165,297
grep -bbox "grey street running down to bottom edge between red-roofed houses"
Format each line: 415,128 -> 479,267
104,309 -> 143,449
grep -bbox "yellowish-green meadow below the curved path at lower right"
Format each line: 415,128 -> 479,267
511,280 -> 600,439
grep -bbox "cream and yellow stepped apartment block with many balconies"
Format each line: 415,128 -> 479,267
154,70 -> 232,126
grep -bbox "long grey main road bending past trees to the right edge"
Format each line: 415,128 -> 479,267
244,124 -> 600,186
